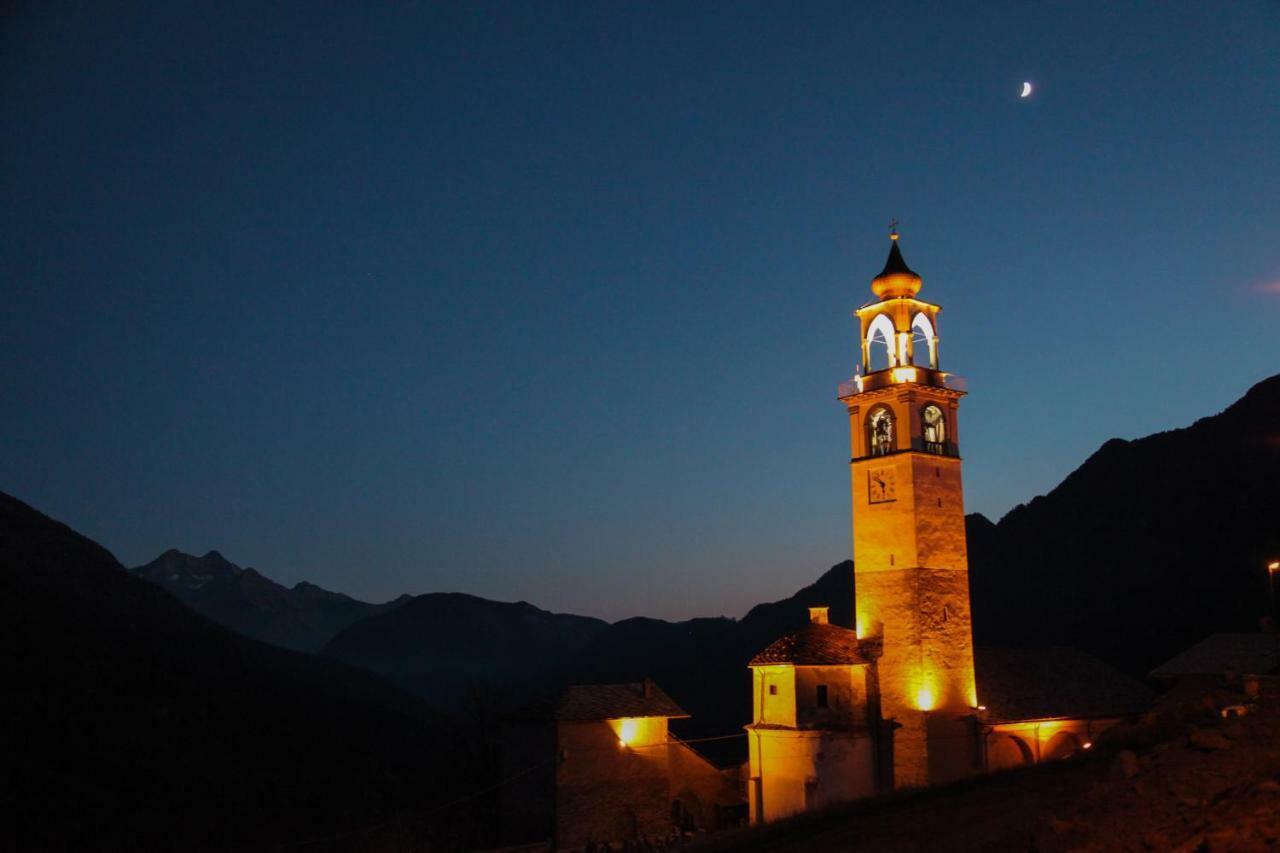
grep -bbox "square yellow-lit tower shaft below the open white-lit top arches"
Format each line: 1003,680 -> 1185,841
845,383 -> 980,786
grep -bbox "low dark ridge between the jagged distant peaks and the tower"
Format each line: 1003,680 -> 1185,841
324,561 -> 854,761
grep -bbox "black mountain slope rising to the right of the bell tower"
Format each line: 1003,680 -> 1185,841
969,377 -> 1280,672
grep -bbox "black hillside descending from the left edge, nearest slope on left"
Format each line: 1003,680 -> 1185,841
0,494 -> 472,850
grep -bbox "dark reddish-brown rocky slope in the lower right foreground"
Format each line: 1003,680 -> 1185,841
708,685 -> 1280,853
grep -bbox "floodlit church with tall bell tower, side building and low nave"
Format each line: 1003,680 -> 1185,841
746,232 -> 1146,824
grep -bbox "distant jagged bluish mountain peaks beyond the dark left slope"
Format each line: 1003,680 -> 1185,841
132,549 -> 410,652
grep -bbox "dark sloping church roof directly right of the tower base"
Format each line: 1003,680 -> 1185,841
974,647 -> 1151,722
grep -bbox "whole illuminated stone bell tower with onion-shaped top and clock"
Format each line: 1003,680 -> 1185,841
840,232 -> 980,788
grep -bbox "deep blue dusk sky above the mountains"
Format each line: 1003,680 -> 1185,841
0,1 -> 1280,620
